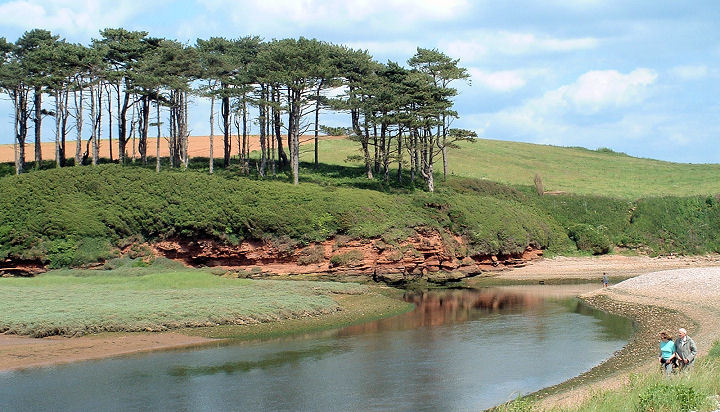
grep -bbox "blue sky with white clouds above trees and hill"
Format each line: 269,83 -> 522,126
0,0 -> 720,163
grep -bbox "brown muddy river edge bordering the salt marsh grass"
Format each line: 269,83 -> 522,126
0,286 -> 415,373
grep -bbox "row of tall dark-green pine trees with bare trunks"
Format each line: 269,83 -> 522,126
0,28 -> 474,191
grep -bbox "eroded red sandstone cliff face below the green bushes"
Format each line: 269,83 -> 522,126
152,232 -> 543,283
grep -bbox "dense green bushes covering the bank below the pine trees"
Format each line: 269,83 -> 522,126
0,165 -> 720,267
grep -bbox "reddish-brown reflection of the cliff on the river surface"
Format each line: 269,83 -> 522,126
342,289 -> 543,335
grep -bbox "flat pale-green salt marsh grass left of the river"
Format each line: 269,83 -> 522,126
0,260 -> 366,337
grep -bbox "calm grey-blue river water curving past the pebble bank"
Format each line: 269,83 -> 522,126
0,286 -> 632,411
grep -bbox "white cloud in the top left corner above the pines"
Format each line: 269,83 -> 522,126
0,0 -> 154,37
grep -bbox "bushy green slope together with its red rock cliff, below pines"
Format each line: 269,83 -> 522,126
0,165 -> 720,276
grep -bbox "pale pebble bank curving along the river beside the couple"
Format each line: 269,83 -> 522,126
524,267 -> 720,410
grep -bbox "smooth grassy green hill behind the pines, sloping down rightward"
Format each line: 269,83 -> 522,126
305,139 -> 720,199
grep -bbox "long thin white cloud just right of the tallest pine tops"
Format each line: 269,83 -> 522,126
441,31 -> 600,61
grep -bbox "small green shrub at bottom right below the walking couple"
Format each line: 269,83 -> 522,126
638,383 -> 707,411
